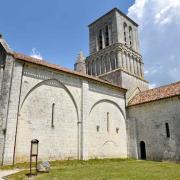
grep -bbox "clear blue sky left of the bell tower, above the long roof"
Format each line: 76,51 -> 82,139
0,0 -> 134,68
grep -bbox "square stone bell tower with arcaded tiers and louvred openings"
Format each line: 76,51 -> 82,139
86,8 -> 148,99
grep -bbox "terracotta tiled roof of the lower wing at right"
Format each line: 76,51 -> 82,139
128,81 -> 180,106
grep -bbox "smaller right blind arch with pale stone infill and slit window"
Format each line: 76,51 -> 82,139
87,99 -> 127,158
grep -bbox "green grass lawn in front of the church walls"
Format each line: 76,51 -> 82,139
8,159 -> 180,180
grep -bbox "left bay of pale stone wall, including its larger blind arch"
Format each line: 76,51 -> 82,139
16,65 -> 81,162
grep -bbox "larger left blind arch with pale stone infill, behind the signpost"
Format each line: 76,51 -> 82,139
14,79 -> 80,162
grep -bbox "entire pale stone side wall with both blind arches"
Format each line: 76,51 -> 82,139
4,61 -> 127,164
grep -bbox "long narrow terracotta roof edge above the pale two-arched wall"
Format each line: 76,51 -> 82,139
14,52 -> 127,92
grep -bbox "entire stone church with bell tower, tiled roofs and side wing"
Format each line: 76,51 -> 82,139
0,8 -> 180,165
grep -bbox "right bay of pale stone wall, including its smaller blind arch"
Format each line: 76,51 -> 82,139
84,83 -> 127,159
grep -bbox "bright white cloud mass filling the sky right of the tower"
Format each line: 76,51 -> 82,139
128,0 -> 180,87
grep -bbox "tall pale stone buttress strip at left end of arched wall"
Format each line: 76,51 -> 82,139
3,61 -> 23,164
